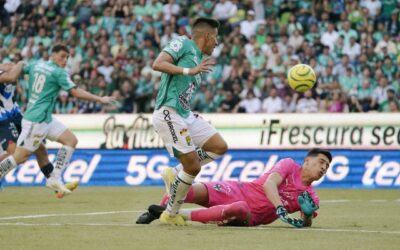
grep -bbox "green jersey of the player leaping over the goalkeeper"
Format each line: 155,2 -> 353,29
156,36 -> 202,118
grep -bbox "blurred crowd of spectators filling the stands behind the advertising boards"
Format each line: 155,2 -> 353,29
0,0 -> 400,113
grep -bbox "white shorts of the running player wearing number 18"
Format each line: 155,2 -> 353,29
17,118 -> 67,152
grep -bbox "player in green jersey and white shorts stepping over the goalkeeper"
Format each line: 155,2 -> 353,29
153,18 -> 227,225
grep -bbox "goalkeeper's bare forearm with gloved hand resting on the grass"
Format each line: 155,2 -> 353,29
263,173 -> 304,228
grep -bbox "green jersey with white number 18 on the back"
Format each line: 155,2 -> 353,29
23,61 -> 76,123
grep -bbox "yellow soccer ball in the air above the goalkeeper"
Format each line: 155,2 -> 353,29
287,64 -> 317,92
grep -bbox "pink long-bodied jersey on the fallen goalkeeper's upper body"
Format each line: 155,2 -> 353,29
242,158 -> 319,225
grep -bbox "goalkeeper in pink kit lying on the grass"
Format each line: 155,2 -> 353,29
136,148 -> 332,228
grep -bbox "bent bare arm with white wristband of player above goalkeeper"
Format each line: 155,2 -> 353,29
152,52 -> 215,75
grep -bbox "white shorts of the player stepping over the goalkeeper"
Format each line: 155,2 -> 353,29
153,106 -> 217,157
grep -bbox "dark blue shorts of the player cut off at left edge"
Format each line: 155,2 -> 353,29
0,114 -> 22,150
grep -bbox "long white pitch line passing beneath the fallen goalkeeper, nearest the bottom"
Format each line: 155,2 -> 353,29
0,222 -> 400,235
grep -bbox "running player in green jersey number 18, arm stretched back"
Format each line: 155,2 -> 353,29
0,45 -> 114,194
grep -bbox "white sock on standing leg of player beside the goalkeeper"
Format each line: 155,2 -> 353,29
166,171 -> 196,216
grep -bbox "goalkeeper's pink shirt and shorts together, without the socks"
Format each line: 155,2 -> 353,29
203,158 -> 319,226
